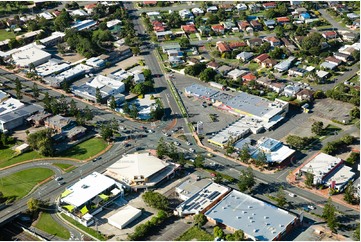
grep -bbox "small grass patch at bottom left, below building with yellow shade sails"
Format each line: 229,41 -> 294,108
35,213 -> 70,240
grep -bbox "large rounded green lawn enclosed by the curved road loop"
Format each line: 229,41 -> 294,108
0,168 -> 54,199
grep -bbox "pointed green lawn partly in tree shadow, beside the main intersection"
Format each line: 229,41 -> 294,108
57,138 -> 108,160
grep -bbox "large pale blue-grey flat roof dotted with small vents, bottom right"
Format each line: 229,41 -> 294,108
205,190 -> 296,241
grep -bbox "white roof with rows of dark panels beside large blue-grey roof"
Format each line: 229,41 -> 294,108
176,182 -> 230,214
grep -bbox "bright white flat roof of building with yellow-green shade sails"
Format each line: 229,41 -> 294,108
61,172 -> 115,207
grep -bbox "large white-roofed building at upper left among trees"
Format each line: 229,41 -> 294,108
12,45 -> 51,68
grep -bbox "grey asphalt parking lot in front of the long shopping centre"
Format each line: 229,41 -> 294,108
173,73 -> 239,134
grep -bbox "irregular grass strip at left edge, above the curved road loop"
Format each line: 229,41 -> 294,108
0,148 -> 43,168
